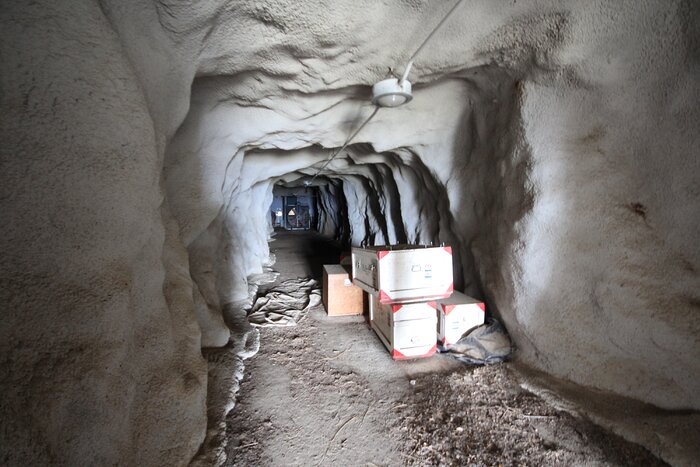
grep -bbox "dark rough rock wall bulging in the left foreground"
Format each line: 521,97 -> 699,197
0,1 -> 206,465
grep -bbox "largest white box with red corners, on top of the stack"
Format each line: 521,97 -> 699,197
352,245 -> 454,304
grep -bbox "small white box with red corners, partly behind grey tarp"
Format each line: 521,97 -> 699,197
437,292 -> 486,347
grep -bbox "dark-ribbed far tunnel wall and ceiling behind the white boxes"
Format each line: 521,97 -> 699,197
245,143 -> 470,286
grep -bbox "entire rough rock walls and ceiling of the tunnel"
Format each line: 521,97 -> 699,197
0,0 -> 700,465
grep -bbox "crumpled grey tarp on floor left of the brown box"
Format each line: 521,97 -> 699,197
248,279 -> 321,326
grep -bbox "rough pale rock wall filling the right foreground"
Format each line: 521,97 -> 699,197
504,2 -> 700,409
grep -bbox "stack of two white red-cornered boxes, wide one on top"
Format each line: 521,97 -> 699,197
352,245 -> 453,360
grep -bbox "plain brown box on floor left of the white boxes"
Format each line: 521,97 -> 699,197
322,264 -> 363,316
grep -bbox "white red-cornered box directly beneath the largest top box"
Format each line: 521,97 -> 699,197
369,295 -> 437,360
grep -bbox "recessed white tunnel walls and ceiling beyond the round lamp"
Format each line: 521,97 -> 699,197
166,68 -> 529,345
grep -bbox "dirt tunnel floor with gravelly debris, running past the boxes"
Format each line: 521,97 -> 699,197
226,233 -> 665,466
